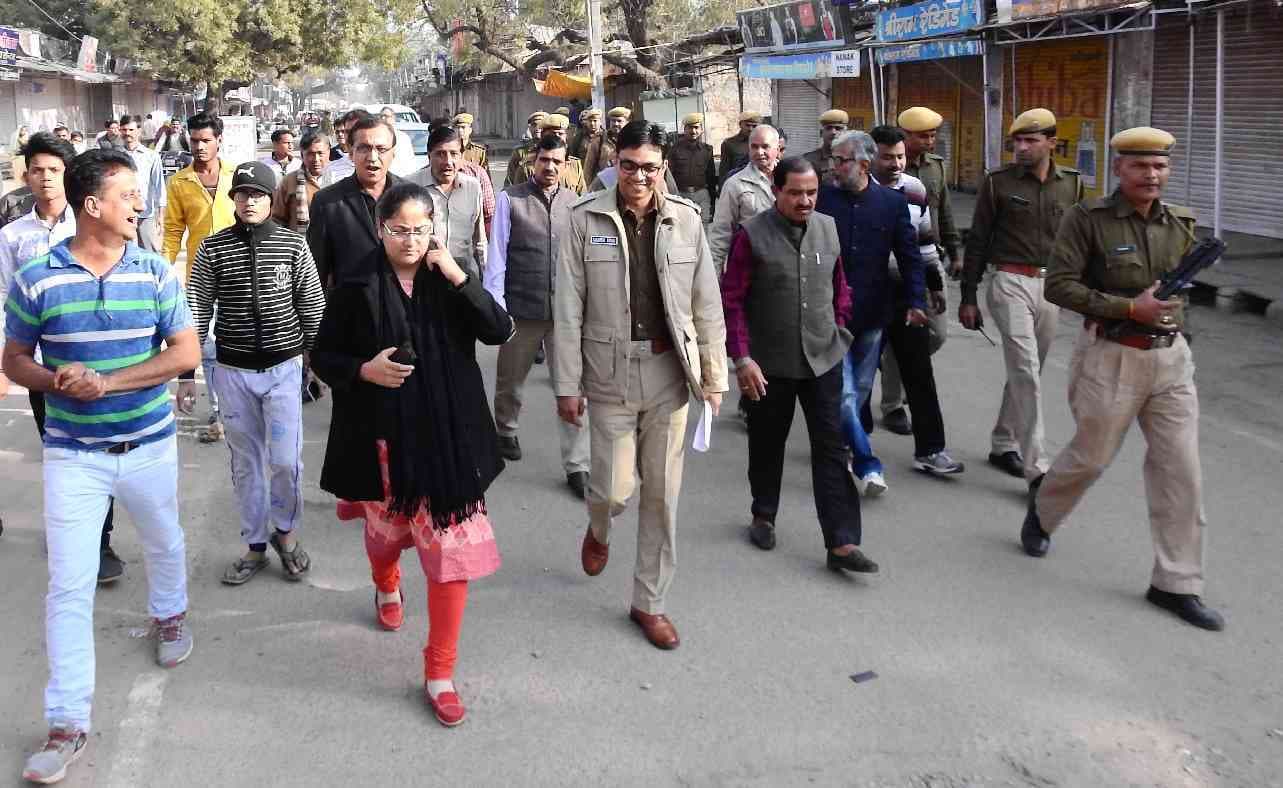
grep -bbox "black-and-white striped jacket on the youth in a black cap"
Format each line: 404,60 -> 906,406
187,219 -> 325,370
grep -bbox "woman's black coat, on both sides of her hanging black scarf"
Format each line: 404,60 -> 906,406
312,259 -> 513,501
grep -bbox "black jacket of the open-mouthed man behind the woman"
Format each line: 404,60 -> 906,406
308,172 -> 400,290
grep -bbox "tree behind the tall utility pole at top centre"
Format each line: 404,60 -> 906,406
420,0 -> 757,89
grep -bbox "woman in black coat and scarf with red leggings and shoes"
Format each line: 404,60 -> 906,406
312,184 -> 513,725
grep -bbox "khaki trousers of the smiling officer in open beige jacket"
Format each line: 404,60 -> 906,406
588,350 -> 690,615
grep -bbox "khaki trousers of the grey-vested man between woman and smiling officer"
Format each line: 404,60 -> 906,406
494,320 -> 589,474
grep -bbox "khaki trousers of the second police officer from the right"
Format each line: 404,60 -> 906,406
987,271 -> 1060,481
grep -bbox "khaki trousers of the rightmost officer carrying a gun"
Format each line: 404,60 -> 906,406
1037,330 -> 1206,594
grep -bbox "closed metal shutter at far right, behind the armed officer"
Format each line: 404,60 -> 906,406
1152,0 -> 1283,237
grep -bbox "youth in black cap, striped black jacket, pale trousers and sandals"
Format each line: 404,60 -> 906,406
186,162 -> 325,585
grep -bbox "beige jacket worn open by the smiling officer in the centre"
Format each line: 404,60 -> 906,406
550,187 -> 727,403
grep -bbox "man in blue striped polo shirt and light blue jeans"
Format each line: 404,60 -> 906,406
4,149 -> 200,783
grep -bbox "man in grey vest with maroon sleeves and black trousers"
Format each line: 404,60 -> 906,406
721,157 -> 878,572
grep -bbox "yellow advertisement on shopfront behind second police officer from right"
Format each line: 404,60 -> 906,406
1002,39 -> 1109,196
